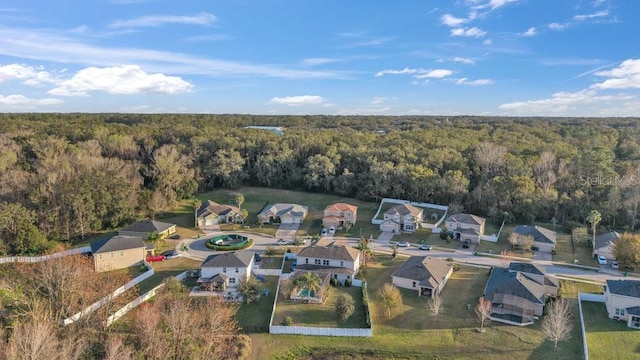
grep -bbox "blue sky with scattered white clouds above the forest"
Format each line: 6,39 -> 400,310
0,0 -> 640,116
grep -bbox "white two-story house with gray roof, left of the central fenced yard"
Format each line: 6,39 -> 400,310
198,251 -> 254,291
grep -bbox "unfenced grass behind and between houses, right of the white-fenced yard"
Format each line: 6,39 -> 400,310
245,255 -> 601,359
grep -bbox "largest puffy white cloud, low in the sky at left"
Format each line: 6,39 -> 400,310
49,65 -> 193,96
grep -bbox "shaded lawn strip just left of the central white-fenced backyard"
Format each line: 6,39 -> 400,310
236,276 -> 278,333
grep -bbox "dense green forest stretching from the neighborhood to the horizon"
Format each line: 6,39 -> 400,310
0,114 -> 640,254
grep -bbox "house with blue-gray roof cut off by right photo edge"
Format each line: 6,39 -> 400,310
604,280 -> 640,329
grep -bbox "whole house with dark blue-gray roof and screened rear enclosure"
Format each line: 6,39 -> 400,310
483,263 -> 559,326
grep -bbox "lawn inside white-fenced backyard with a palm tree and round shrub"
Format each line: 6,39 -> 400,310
274,286 -> 367,328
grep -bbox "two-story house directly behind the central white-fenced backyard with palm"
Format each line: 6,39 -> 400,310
296,243 -> 360,283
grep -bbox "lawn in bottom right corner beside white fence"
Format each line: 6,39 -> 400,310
582,301 -> 640,360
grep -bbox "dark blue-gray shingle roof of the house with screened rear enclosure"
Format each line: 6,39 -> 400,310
484,268 -> 545,305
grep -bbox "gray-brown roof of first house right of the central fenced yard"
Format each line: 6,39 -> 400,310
391,256 -> 451,289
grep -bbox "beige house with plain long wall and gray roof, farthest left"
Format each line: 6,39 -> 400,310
90,235 -> 147,272
